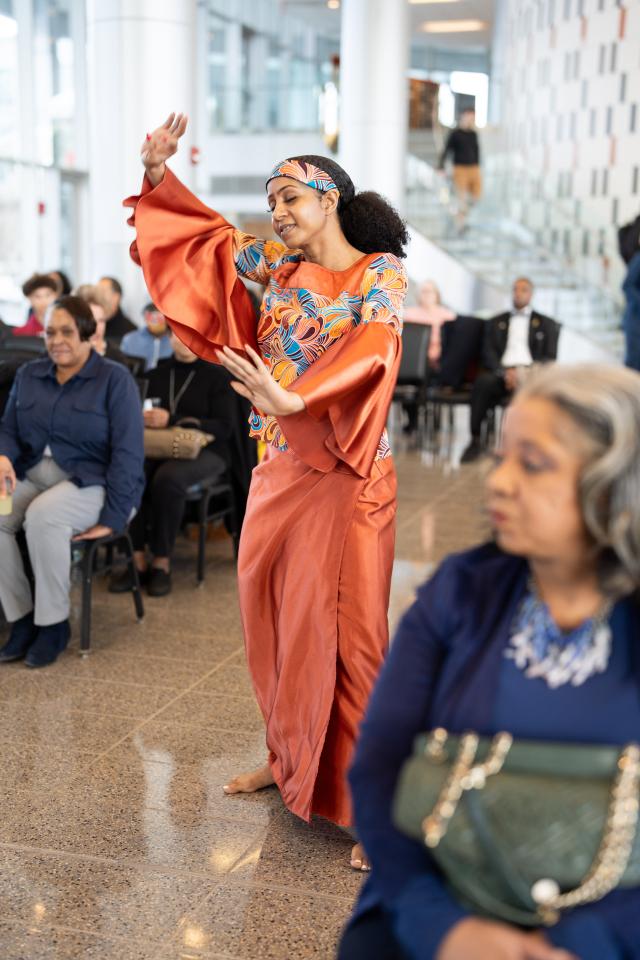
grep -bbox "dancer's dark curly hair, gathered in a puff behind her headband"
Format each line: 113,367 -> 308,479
272,153 -> 409,257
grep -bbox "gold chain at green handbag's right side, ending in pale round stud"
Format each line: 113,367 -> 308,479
531,743 -> 640,926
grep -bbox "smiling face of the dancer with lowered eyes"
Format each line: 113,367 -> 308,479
267,177 -> 340,249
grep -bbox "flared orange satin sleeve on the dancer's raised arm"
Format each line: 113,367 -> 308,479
124,169 -> 257,362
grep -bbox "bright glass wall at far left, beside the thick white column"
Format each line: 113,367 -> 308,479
0,0 -> 88,323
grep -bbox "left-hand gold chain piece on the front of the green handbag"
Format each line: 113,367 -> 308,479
422,727 -> 513,849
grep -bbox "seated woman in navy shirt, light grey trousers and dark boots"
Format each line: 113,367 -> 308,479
0,297 -> 144,667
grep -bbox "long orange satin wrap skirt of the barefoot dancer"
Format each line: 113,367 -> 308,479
238,447 -> 396,827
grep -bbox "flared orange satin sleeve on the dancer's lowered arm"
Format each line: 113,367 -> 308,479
278,323 -> 402,477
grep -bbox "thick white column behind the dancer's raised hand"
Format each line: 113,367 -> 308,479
87,0 -> 196,316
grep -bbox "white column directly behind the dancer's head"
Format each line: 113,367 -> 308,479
339,0 -> 409,211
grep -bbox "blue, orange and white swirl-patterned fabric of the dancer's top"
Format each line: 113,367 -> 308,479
235,231 -> 407,460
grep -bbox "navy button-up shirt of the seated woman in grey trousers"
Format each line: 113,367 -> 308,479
0,350 -> 144,530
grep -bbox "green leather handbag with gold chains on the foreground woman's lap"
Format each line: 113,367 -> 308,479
393,728 -> 640,926
